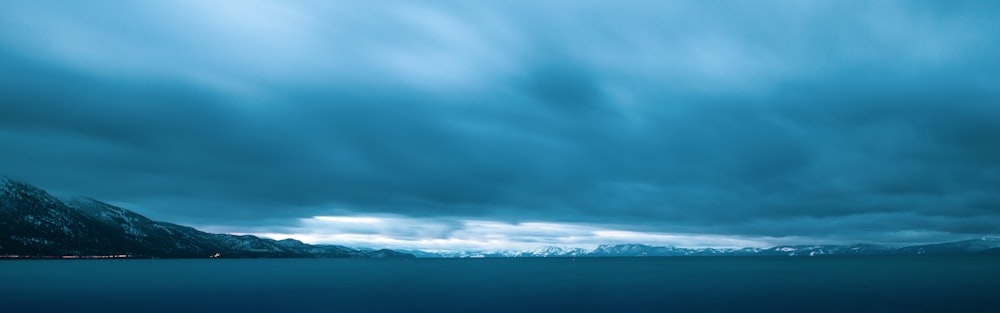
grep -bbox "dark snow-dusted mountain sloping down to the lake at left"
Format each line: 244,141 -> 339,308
0,177 -> 413,258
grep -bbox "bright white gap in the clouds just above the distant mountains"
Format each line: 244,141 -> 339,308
232,216 -> 775,251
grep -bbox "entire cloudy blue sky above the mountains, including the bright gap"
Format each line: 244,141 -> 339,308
0,0 -> 1000,250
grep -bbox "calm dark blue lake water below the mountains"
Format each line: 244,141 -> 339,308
0,257 -> 1000,312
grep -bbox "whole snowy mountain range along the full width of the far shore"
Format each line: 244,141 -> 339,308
0,177 -> 1000,258
